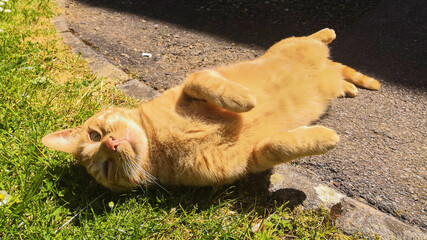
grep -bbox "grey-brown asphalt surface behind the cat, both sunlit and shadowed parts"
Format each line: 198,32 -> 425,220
61,0 -> 427,230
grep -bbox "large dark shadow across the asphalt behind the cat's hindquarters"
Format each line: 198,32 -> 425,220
72,0 -> 427,87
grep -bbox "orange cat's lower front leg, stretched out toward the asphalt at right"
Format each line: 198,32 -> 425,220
249,126 -> 339,172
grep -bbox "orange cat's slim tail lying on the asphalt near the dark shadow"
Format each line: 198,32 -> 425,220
334,62 -> 381,90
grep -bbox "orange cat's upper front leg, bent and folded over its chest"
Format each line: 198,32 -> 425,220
183,70 -> 256,113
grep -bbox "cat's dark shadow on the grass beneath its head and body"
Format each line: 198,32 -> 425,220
46,164 -> 306,225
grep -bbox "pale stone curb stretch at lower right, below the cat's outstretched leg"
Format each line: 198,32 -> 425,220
269,164 -> 427,240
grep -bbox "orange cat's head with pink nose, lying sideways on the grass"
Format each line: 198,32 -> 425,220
42,108 -> 150,191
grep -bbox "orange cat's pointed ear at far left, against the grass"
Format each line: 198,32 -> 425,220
42,127 -> 81,154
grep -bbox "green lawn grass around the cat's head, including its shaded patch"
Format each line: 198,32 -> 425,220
0,0 -> 368,239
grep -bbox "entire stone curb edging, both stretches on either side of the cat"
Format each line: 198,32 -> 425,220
53,0 -> 427,240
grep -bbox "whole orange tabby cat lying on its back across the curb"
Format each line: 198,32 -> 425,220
42,29 -> 380,191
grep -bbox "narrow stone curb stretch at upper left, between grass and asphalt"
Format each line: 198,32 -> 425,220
52,0 -> 160,100
